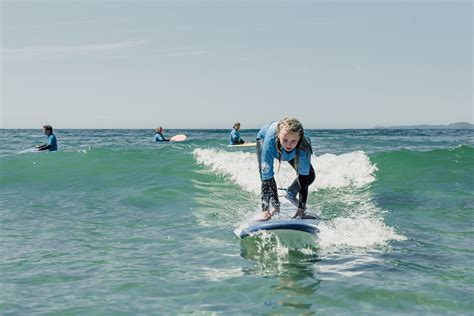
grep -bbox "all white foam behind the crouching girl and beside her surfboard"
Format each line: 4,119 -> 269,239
193,149 -> 406,252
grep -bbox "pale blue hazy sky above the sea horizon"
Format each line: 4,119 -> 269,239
0,0 -> 474,130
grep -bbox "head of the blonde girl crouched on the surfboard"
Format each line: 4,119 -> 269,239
275,117 -> 304,152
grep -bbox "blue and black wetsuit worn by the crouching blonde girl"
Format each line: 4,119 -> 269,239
257,122 -> 316,211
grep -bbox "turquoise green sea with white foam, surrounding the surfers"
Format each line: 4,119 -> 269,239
0,130 -> 474,315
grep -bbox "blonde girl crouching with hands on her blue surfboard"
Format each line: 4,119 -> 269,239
257,117 -> 316,220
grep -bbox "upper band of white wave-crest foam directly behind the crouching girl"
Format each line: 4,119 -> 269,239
193,149 -> 377,194
